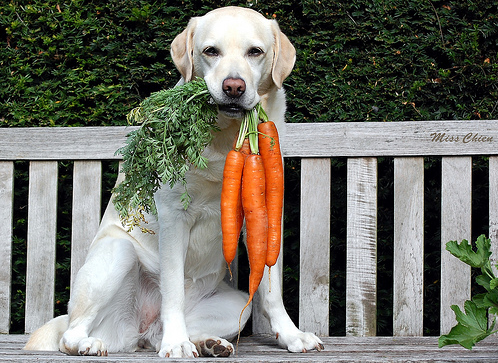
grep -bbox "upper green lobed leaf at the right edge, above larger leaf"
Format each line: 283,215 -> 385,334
446,235 -> 491,268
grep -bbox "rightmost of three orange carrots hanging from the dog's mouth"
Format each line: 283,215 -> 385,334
258,121 -> 284,267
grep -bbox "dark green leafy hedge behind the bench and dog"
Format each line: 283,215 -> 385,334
0,0 -> 498,335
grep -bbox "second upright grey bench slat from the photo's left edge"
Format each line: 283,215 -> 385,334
25,161 -> 58,333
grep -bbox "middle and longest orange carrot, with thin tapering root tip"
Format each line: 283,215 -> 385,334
240,154 -> 268,317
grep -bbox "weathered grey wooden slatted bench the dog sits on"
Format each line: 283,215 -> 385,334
0,121 -> 498,362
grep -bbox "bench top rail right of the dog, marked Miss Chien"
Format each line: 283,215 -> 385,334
281,120 -> 498,157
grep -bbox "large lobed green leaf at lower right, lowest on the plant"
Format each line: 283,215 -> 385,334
439,300 -> 494,349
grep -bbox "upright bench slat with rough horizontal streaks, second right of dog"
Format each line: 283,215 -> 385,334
346,158 -> 377,336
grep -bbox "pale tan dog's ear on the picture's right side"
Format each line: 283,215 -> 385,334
272,20 -> 296,88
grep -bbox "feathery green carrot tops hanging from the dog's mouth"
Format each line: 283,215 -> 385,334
113,79 -> 218,229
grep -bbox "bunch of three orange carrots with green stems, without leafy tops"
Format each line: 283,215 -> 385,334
221,105 -> 284,315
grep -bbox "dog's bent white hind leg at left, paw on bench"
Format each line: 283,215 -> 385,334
59,237 -> 139,355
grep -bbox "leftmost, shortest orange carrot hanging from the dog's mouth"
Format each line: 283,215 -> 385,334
221,150 -> 244,275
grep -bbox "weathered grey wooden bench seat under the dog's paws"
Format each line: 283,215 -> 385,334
6,335 -> 498,363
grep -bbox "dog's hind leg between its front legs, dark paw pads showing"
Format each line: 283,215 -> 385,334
186,282 -> 251,357
